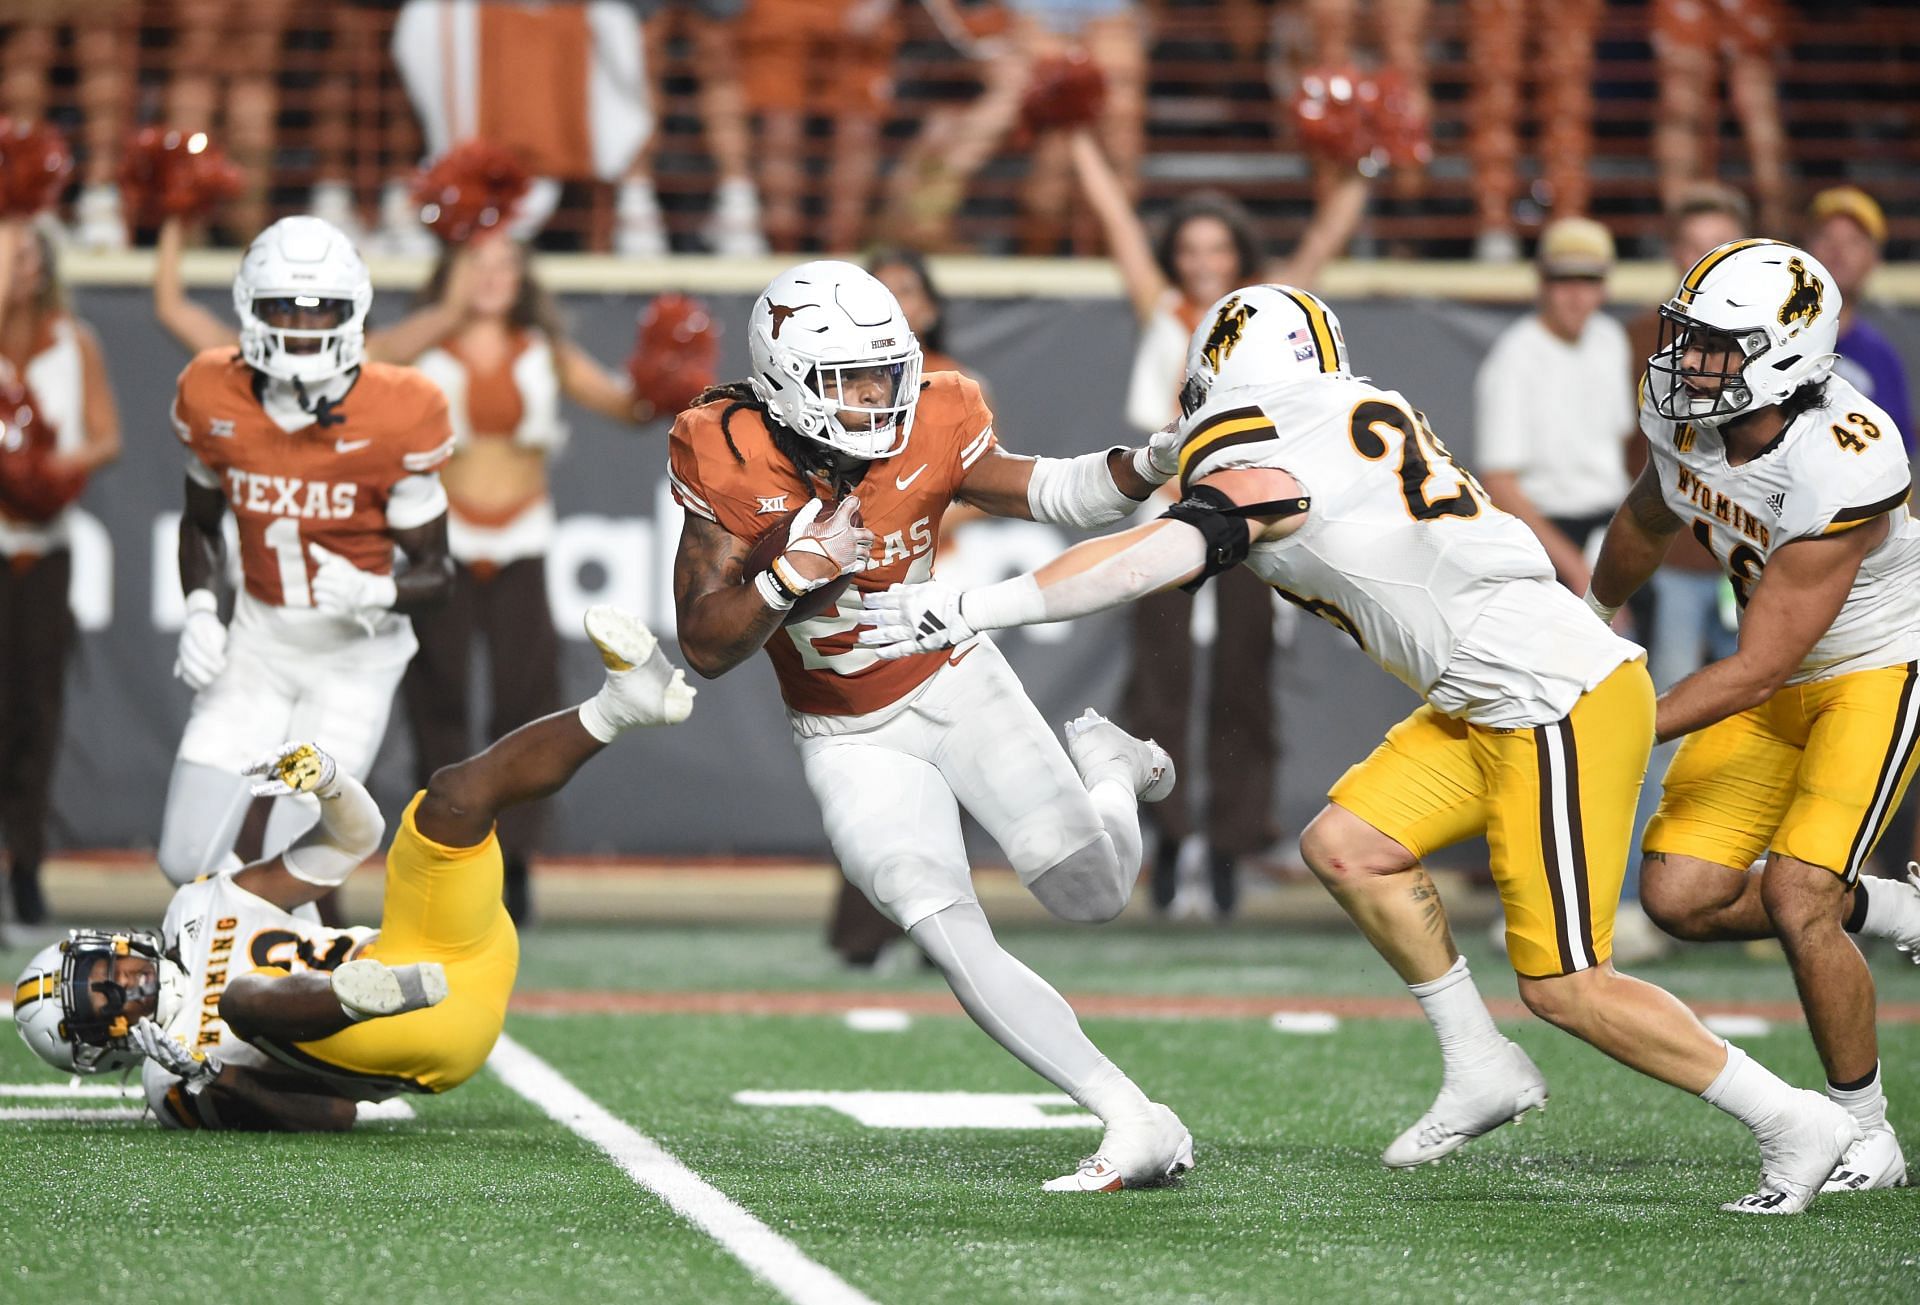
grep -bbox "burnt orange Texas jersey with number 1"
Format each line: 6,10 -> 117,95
173,347 -> 453,606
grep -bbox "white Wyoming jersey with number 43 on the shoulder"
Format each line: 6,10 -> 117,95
1640,376 -> 1920,685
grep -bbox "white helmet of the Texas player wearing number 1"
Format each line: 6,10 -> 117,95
234,217 -> 372,386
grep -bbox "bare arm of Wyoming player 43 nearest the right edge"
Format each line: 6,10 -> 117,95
1653,518 -> 1887,743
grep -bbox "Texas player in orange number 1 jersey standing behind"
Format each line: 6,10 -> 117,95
159,217 -> 453,883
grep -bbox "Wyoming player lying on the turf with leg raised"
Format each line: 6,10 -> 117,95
13,606 -> 693,1130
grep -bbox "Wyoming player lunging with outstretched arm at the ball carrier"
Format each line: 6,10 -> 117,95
862,286 -> 1859,1213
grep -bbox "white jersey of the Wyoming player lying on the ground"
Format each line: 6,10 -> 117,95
140,875 -> 374,1128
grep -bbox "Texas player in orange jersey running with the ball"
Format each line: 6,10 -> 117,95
670,261 -> 1192,1192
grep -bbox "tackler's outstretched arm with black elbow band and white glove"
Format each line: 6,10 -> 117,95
860,468 -> 1304,660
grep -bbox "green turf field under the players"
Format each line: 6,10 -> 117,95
0,927 -> 1920,1305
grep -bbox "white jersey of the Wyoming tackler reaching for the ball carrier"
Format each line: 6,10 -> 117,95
1181,376 -> 1642,729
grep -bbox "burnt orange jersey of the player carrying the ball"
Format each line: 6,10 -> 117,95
668,372 -> 995,716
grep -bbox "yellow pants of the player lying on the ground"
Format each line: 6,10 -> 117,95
275,793 -> 520,1092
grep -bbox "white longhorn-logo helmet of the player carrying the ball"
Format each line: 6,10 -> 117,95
747,259 -> 920,461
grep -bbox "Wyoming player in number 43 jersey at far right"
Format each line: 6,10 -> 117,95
1590,240 -> 1920,1192
